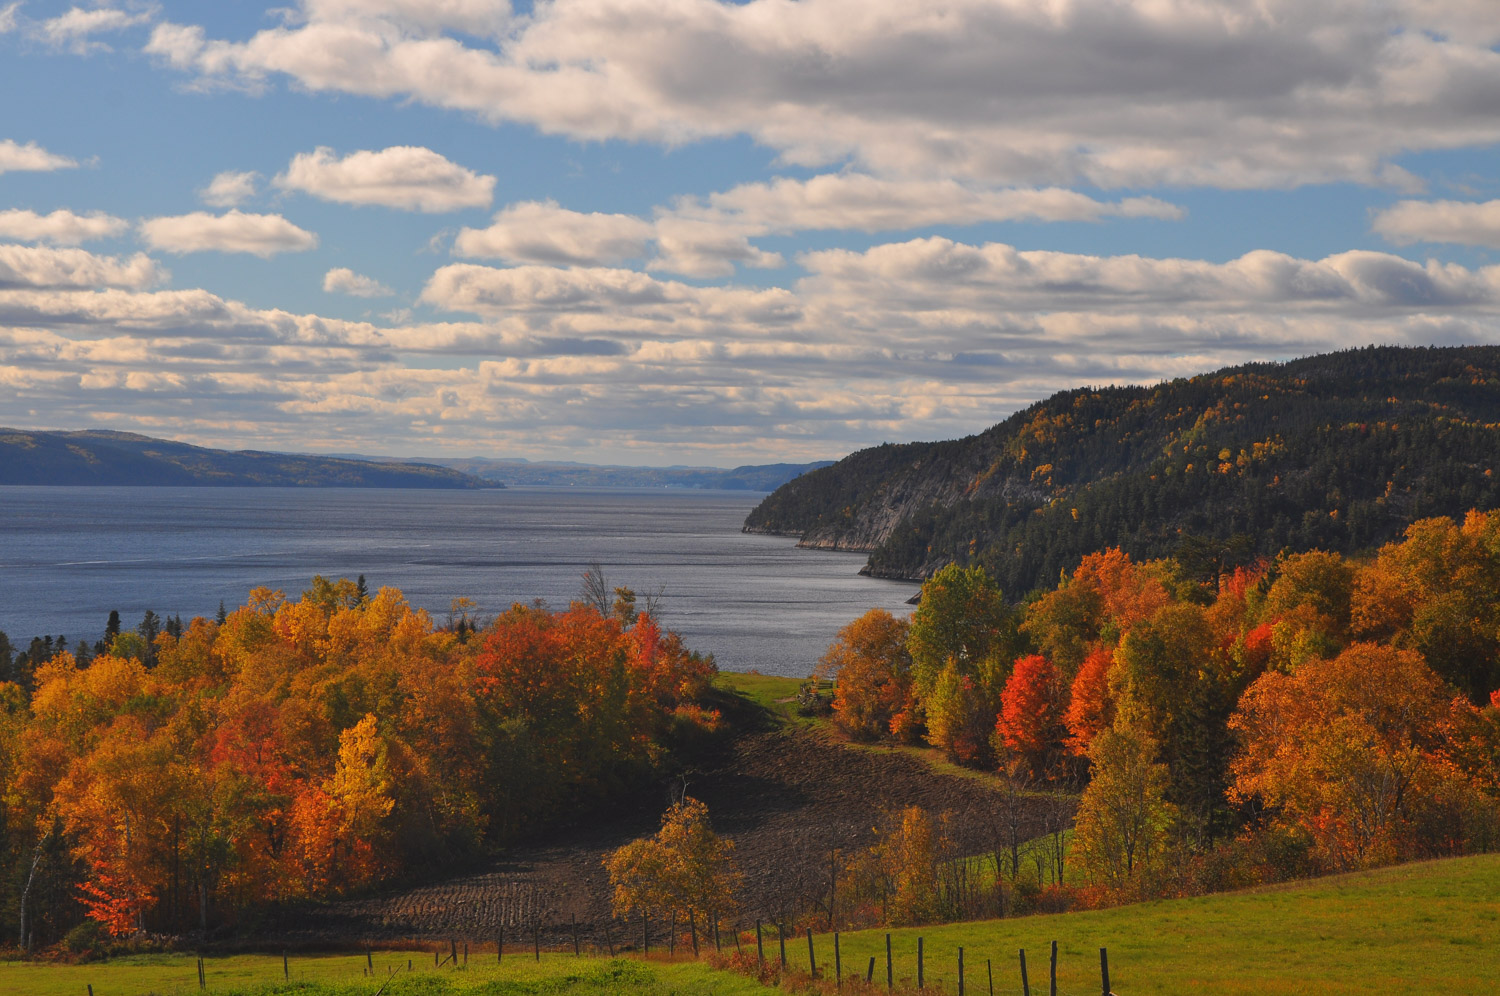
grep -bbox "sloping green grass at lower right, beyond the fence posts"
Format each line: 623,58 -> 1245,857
768,855 -> 1500,996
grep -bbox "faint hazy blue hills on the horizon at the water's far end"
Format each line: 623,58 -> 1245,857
437,458 -> 833,491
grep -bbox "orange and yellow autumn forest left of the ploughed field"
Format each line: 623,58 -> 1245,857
0,578 -> 717,948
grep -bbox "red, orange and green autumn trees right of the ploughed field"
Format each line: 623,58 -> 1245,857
821,512 -> 1500,923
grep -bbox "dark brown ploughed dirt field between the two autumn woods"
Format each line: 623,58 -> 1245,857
278,690 -> 1062,950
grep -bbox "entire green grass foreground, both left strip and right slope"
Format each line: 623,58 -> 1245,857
17,855 -> 1500,996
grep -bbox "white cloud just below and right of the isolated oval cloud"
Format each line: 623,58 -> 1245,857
453,201 -> 654,264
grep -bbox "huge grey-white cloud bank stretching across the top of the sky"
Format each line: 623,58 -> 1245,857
149,0 -> 1500,188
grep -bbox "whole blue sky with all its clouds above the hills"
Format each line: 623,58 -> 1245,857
0,0 -> 1500,467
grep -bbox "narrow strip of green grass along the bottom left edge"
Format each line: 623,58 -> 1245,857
0,951 -> 765,996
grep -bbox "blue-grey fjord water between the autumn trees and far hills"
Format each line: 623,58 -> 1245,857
0,488 -> 914,677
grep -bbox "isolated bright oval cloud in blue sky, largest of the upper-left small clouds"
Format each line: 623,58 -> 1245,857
275,146 -> 495,213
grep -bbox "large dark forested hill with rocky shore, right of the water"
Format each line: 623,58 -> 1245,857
746,347 -> 1500,596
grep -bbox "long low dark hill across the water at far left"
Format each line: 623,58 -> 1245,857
0,429 -> 503,488
